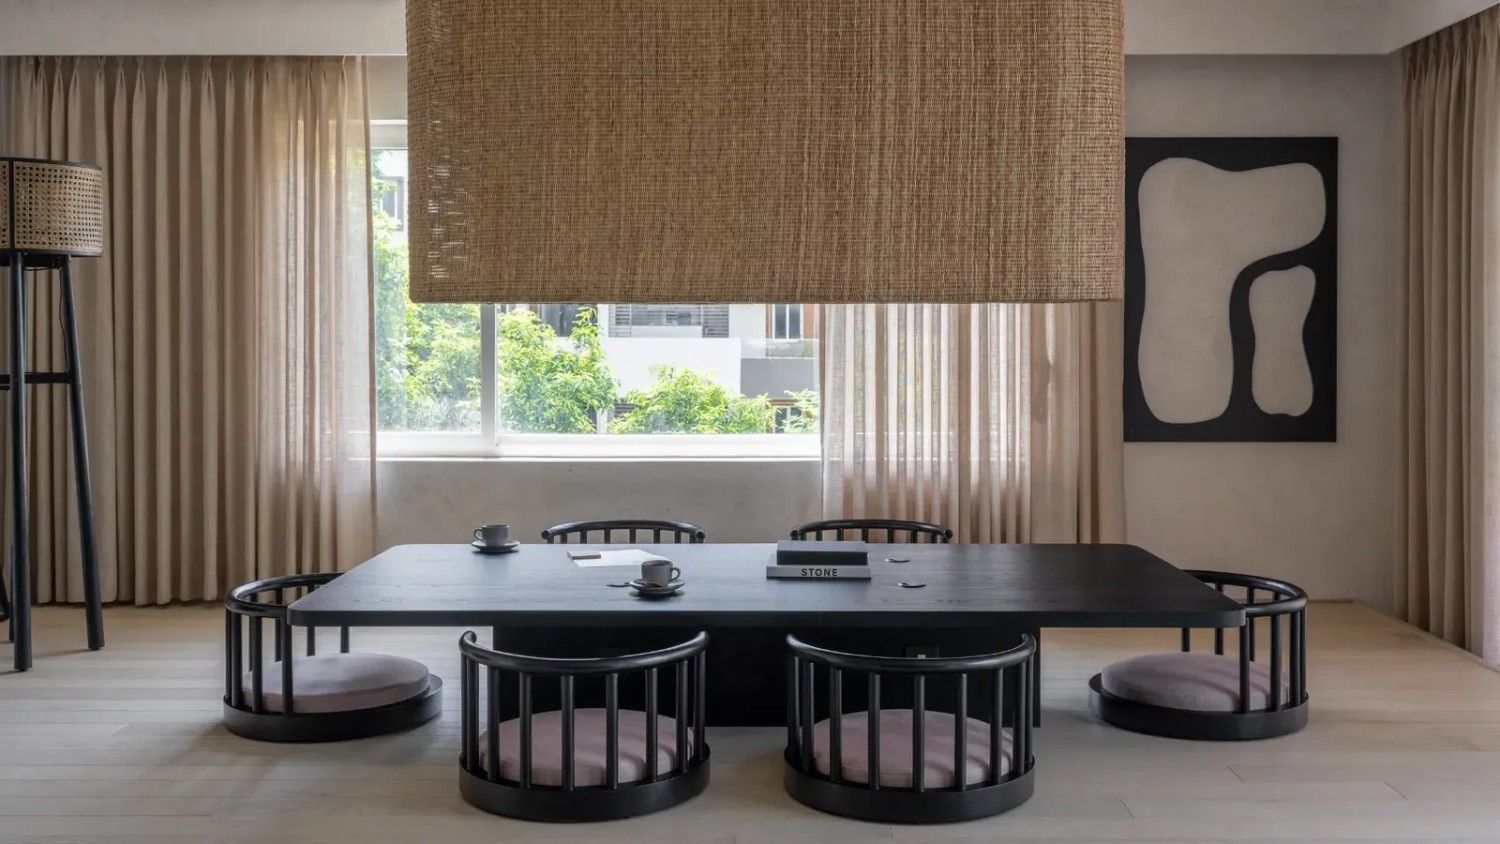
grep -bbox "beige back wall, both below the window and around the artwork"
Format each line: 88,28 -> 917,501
380,57 -> 1400,607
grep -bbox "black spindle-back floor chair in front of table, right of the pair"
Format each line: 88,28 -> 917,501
783,636 -> 1037,823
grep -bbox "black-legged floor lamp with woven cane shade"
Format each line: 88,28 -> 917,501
0,157 -> 104,672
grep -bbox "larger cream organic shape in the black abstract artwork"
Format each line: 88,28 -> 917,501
1139,157 -> 1328,423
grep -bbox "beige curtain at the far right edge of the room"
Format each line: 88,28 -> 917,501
1395,9 -> 1500,663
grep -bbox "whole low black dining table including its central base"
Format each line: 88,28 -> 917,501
288,543 -> 1245,724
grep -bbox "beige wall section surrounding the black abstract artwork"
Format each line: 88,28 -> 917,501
1125,57 -> 1400,609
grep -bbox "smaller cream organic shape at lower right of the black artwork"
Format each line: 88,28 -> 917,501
1250,267 -> 1317,417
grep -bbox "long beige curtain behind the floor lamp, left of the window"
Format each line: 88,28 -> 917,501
5,57 -> 374,604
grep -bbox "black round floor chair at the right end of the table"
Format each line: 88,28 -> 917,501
1089,571 -> 1308,741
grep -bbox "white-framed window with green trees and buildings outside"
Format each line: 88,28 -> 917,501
372,124 -> 818,457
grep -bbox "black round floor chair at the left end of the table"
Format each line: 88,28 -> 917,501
224,574 -> 443,742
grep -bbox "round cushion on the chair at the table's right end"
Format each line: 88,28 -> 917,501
1100,654 -> 1292,712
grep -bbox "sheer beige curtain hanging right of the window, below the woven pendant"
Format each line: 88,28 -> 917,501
822,304 -> 1125,543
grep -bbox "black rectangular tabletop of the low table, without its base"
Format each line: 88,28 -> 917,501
290,544 -> 1245,630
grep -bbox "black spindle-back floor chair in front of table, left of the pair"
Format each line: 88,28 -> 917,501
459,631 -> 708,822
